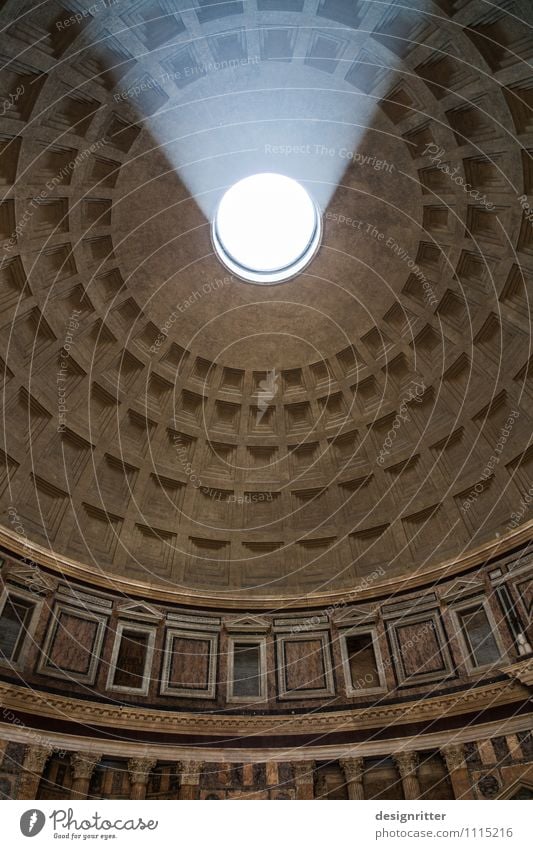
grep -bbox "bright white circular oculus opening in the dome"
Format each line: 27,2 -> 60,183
213,173 -> 321,283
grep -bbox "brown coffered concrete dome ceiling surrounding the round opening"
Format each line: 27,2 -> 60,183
0,0 -> 533,604
